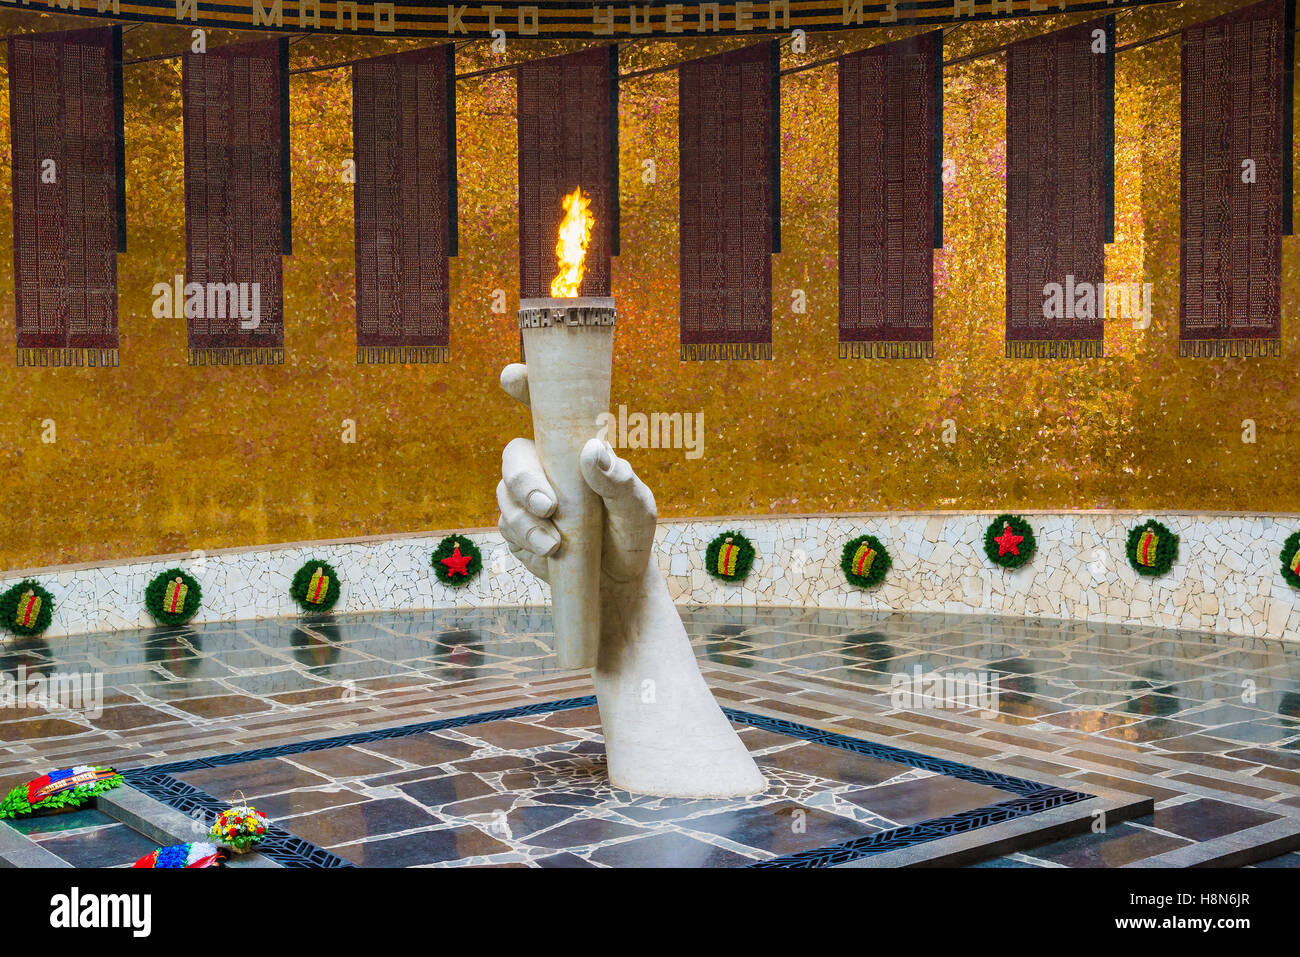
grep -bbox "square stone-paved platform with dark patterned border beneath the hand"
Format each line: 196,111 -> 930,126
126,698 -> 1089,867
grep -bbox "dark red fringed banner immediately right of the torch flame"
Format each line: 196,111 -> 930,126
677,42 -> 780,360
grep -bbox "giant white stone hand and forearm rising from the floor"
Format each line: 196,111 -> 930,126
497,363 -> 766,797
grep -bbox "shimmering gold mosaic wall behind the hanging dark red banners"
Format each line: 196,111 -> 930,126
0,3 -> 1300,568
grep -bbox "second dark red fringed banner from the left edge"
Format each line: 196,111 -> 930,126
182,39 -> 290,365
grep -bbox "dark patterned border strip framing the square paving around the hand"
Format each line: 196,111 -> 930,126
122,694 -> 1092,867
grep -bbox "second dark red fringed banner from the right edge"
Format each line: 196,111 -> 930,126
1006,18 -> 1114,358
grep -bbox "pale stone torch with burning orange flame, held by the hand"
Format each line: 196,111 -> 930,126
519,189 -> 616,668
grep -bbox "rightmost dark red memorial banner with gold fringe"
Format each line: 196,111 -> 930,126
1178,0 -> 1290,356
